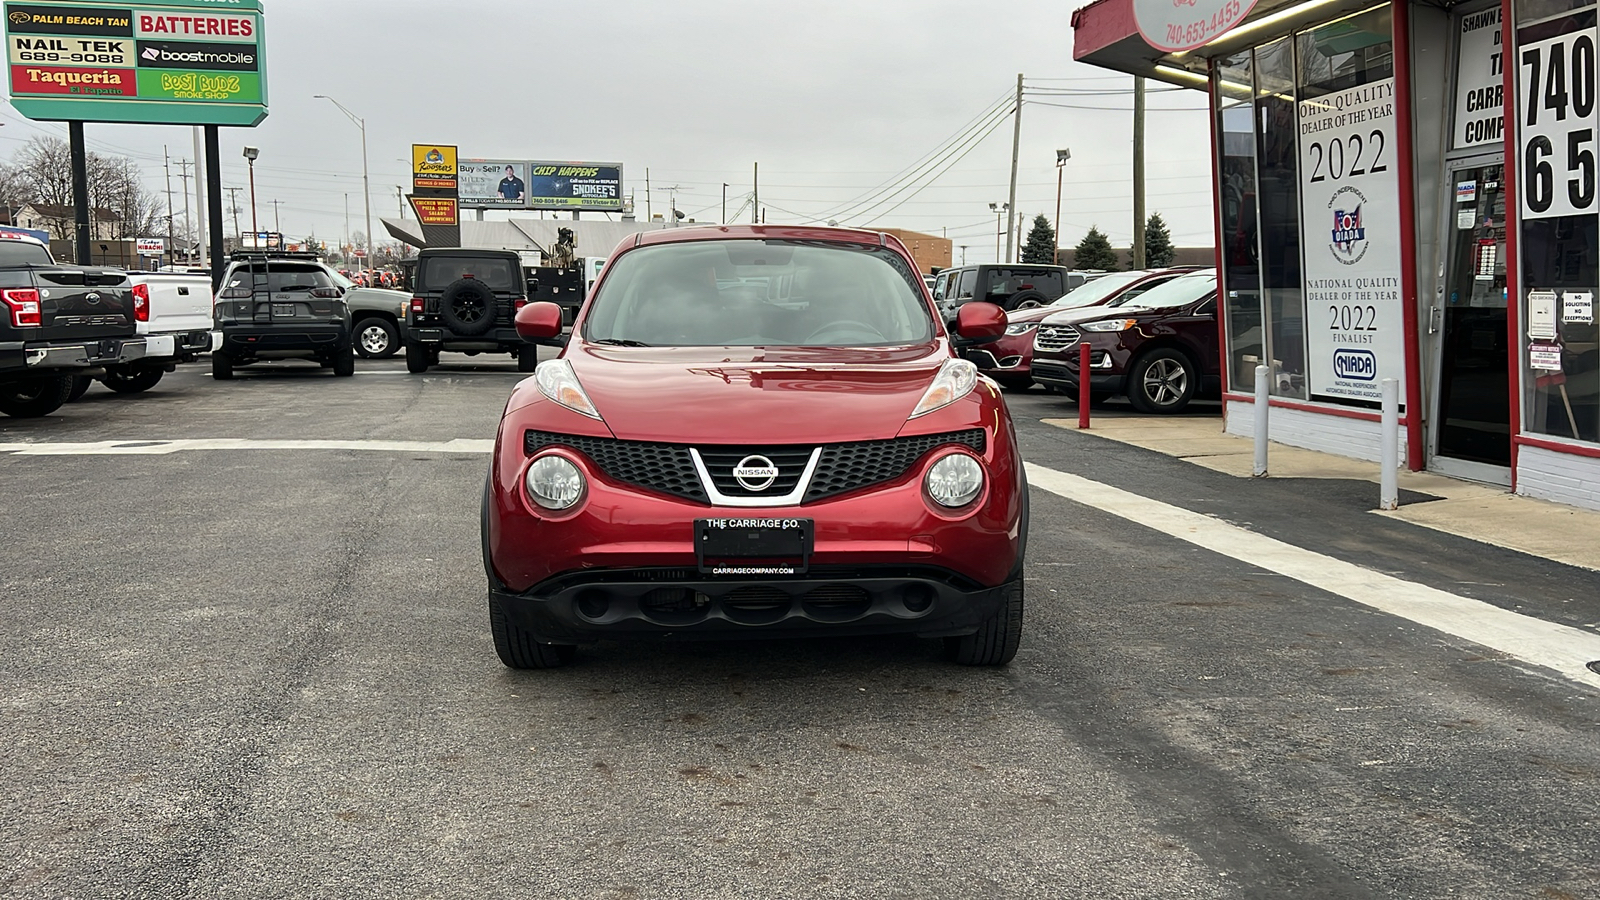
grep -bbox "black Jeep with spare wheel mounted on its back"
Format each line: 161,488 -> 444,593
405,247 -> 539,373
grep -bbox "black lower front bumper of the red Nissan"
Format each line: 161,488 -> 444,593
490,567 -> 1005,644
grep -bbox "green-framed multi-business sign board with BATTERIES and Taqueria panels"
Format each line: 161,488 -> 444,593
5,0 -> 267,127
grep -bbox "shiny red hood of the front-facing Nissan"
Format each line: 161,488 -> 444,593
565,341 -> 950,444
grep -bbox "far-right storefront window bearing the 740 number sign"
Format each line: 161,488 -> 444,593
1517,5 -> 1600,442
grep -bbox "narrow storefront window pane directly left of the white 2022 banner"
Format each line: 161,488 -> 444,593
1256,38 -> 1306,399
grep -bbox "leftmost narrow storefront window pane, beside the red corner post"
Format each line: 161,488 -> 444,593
1214,50 -> 1266,394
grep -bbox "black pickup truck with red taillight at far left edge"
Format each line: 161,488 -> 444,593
0,231 -> 144,418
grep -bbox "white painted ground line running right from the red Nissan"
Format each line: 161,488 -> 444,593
1027,463 -> 1600,687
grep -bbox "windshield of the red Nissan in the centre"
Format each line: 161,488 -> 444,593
584,240 -> 933,348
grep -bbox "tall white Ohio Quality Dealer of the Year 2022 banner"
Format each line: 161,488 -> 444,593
1299,78 -> 1405,400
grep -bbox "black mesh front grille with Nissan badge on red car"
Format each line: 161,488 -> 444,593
523,428 -> 987,504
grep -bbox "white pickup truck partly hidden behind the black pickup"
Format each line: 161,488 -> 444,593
74,271 -> 211,392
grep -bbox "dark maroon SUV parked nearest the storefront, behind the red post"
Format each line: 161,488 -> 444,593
1034,269 -> 1222,413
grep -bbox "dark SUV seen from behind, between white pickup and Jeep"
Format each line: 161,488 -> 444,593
211,250 -> 355,381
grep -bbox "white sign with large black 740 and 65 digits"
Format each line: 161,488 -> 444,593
1518,29 -> 1597,219
